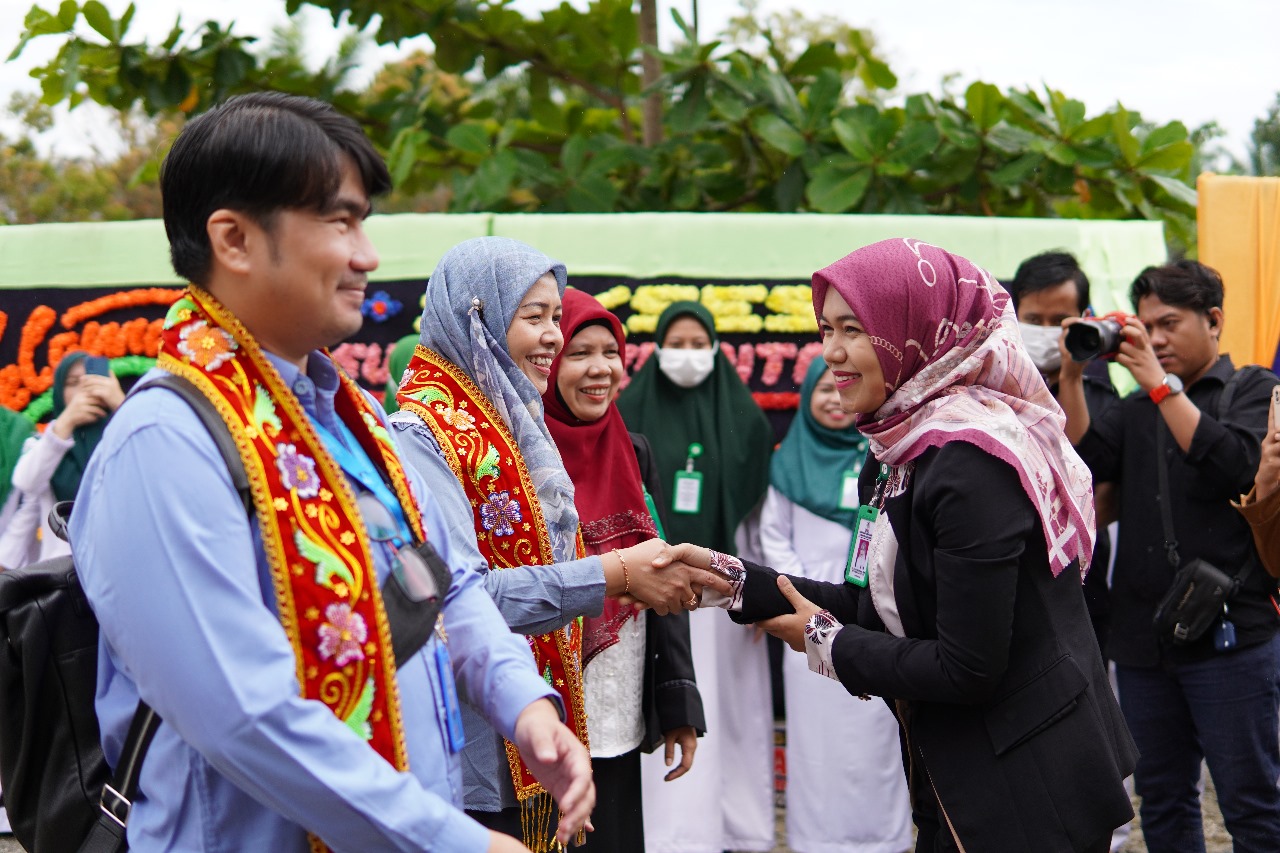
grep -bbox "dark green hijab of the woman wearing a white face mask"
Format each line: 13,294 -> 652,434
617,302 -> 773,553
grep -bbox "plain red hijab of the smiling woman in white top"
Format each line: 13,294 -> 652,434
543,288 -> 658,665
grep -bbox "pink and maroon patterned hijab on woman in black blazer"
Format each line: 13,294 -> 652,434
813,238 -> 1094,576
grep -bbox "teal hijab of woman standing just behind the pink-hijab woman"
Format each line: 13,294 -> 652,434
769,359 -> 867,530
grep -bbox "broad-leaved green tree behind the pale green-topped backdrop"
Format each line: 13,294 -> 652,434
7,0 -> 1197,248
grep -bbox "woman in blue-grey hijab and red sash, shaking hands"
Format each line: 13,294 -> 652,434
390,237 -> 593,850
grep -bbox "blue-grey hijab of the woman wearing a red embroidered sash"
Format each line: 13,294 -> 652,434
419,237 -> 577,562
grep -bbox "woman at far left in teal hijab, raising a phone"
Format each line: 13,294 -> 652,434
0,352 -> 124,560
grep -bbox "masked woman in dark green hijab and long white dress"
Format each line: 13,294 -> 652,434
617,302 -> 773,853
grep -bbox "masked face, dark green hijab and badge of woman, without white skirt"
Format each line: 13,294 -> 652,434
618,302 -> 773,553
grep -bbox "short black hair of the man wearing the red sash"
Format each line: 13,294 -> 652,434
160,92 -> 392,284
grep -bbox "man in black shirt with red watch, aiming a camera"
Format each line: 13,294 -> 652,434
1059,260 -> 1280,853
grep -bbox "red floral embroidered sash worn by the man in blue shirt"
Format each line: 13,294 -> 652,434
159,287 -> 425,853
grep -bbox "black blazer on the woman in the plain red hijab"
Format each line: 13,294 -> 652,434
630,433 -> 707,752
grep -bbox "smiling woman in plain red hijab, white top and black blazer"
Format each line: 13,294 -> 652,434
543,289 -> 707,853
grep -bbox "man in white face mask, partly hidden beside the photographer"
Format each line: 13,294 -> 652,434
1009,252 -> 1117,648
